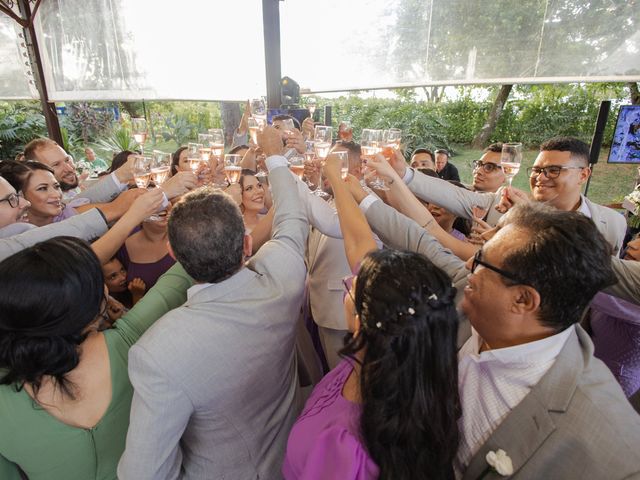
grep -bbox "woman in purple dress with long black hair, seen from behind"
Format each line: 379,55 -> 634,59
283,155 -> 460,480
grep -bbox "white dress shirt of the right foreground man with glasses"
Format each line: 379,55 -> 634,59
454,325 -> 575,478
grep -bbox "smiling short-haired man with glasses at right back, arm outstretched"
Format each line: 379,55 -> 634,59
393,137 -> 626,253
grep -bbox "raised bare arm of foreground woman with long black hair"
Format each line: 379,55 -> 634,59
324,154 -> 378,271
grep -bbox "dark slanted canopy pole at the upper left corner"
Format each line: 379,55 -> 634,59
17,0 -> 64,146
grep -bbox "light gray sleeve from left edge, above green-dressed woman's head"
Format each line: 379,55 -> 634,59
0,208 -> 107,260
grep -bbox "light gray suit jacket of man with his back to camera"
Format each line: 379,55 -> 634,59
118,167 -> 309,480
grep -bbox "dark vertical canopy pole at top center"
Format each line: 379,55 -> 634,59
262,0 -> 282,108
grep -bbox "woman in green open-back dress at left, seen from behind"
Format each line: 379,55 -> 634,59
0,237 -> 192,480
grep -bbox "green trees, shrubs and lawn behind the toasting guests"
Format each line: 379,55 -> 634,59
0,83 -> 637,204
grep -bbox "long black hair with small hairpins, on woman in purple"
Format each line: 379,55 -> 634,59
340,250 -> 461,480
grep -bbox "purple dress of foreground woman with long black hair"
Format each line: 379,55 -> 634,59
282,360 -> 378,480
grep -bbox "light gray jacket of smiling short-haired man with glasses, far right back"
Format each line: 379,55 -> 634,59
407,171 -> 627,254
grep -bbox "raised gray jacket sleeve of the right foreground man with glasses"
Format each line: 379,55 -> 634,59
365,197 -> 471,348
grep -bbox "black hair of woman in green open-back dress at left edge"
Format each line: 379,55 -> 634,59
0,237 -> 104,398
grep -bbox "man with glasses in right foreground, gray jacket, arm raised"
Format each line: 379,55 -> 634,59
354,192 -> 640,480
